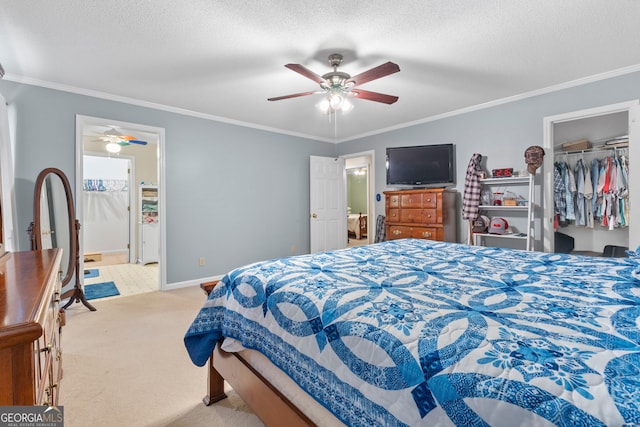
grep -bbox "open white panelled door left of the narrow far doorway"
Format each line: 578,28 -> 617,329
309,156 -> 347,253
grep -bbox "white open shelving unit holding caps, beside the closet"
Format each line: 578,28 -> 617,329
473,175 -> 535,251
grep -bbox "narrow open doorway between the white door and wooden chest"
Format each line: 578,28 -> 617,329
344,152 -> 374,247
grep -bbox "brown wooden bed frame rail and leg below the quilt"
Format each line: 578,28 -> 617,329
200,280 -> 315,426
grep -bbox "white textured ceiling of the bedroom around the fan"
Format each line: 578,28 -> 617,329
0,0 -> 640,142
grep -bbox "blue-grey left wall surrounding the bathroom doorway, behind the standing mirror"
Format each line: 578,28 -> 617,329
0,80 -> 336,284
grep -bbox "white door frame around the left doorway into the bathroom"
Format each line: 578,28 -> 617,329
75,114 -> 167,291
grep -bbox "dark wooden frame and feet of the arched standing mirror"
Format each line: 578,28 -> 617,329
29,168 -> 96,311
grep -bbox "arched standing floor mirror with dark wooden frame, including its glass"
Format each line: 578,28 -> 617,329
29,168 -> 95,311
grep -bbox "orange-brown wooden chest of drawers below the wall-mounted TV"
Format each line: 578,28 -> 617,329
384,188 -> 457,242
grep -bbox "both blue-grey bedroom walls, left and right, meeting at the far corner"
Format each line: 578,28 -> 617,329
0,72 -> 640,284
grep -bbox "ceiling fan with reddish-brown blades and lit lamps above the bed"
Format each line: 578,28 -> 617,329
268,53 -> 400,111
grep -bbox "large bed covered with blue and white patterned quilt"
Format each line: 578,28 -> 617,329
184,239 -> 640,426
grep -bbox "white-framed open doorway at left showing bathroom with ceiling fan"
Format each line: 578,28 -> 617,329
76,116 -> 166,296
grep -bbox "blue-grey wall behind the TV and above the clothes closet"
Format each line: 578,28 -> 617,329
338,72 -> 640,242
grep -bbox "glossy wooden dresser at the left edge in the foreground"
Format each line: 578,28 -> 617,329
0,249 -> 64,406
